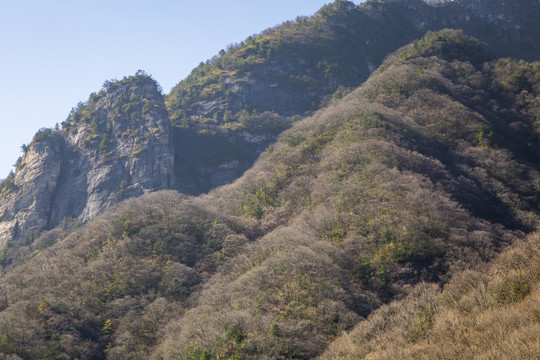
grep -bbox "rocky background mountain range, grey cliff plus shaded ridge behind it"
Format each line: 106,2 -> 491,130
0,0 -> 540,253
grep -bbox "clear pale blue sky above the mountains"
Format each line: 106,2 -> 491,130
0,0 -> 360,178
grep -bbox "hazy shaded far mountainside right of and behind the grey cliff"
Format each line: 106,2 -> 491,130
166,0 -> 540,194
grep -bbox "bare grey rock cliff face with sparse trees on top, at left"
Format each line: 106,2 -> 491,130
0,75 -> 176,247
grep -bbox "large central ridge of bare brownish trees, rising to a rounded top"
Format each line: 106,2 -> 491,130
152,31 -> 540,359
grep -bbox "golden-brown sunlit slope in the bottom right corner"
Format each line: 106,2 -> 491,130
320,233 -> 540,360
